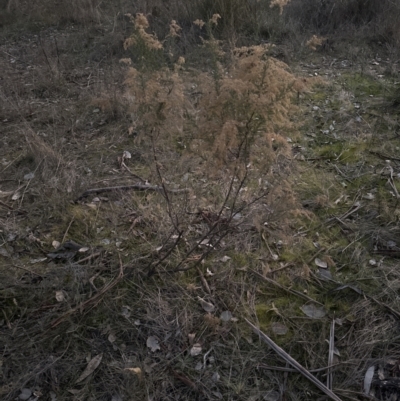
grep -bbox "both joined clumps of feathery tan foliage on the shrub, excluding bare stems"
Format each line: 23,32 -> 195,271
124,37 -> 304,169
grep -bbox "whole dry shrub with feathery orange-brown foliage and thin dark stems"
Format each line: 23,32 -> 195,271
123,15 -> 310,244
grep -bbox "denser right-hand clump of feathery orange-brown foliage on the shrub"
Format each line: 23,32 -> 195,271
197,46 -> 296,169
